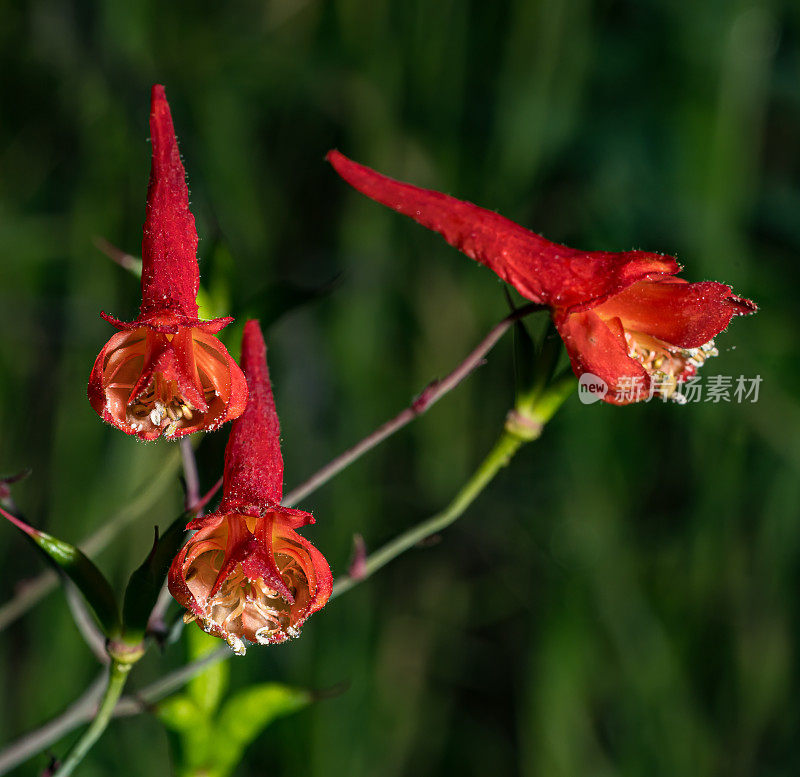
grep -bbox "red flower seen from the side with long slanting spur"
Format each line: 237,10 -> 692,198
327,151 -> 757,404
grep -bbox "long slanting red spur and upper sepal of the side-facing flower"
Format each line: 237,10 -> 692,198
327,151 -> 680,310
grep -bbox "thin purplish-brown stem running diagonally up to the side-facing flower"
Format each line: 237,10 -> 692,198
282,303 -> 543,507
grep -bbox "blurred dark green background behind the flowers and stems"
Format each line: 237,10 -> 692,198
0,0 -> 800,777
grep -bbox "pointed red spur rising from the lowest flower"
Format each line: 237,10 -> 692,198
219,320 -> 290,515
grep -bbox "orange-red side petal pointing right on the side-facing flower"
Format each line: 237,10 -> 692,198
595,278 -> 757,348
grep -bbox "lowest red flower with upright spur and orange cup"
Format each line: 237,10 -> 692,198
169,321 -> 332,654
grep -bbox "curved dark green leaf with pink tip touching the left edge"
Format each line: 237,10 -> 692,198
0,508 -> 120,637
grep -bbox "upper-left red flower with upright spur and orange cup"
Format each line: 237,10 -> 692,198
88,85 -> 247,440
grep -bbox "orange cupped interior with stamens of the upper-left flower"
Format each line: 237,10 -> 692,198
103,327 -> 236,439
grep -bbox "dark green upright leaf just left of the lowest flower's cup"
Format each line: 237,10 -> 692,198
122,513 -> 190,643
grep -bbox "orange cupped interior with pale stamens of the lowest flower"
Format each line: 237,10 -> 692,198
183,515 -> 316,655
